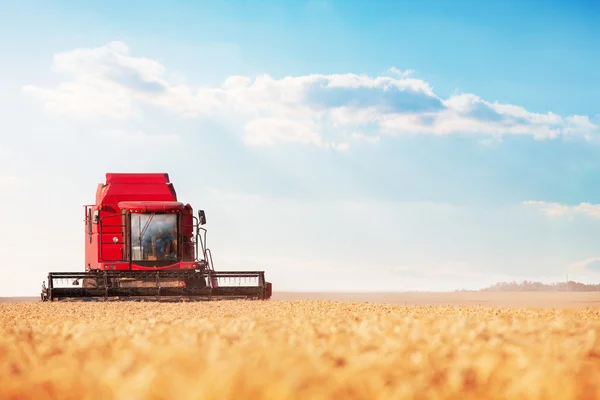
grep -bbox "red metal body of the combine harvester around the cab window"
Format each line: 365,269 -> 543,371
85,173 -> 198,270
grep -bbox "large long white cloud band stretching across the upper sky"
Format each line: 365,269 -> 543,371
23,42 -> 598,148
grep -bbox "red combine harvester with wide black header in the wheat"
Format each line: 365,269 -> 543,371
41,173 -> 271,301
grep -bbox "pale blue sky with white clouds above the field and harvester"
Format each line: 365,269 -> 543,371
0,0 -> 600,295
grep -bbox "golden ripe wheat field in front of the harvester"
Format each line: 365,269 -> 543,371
0,300 -> 600,400
